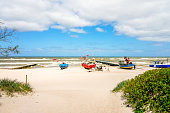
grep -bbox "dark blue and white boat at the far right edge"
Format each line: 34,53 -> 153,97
149,61 -> 170,68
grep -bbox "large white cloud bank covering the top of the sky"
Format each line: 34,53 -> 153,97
0,0 -> 170,42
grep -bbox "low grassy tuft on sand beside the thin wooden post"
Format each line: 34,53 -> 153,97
0,78 -> 33,97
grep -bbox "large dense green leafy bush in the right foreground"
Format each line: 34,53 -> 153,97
113,68 -> 170,113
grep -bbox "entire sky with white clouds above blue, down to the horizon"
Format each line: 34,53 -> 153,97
0,0 -> 170,56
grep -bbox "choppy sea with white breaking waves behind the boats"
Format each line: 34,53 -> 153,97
0,56 -> 170,68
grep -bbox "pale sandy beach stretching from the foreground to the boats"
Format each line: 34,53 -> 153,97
0,66 -> 151,113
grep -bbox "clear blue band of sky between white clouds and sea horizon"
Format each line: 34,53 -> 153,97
14,25 -> 170,56
